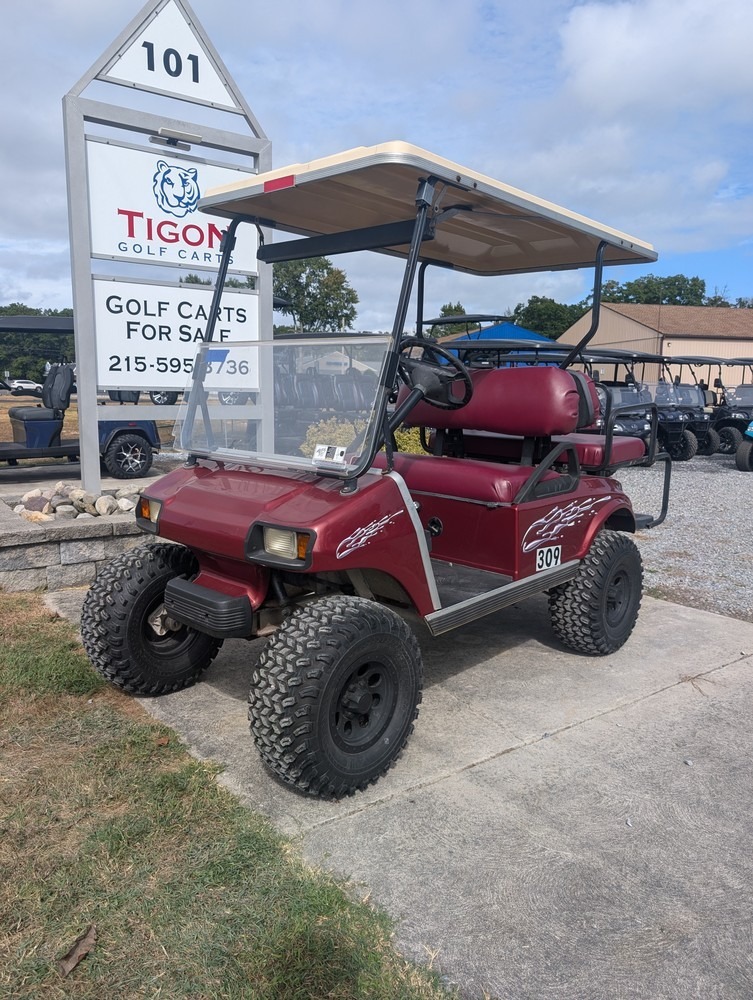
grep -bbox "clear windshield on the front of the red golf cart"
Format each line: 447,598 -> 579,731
176,335 -> 390,477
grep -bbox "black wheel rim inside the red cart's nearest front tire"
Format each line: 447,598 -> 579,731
330,660 -> 398,753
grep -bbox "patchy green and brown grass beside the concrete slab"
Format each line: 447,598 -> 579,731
0,593 -> 448,1000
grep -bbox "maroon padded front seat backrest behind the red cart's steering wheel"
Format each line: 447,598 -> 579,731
398,365 -> 580,437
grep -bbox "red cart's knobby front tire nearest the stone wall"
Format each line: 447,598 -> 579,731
81,543 -> 222,695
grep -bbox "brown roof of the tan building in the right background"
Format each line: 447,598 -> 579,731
601,302 -> 753,340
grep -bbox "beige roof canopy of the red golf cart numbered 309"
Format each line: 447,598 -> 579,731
199,142 -> 657,275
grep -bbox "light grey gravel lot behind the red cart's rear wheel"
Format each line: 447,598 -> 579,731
616,455 -> 753,622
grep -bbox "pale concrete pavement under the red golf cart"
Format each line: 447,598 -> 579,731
47,591 -> 753,1000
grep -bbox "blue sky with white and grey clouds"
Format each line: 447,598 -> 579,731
0,0 -> 753,330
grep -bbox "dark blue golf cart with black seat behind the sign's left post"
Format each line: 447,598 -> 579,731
0,364 -> 160,479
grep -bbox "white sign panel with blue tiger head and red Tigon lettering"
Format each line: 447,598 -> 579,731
86,137 -> 258,274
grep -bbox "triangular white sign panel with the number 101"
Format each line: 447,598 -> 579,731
100,0 -> 238,111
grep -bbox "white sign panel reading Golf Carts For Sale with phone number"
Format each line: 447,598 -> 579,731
93,278 -> 259,389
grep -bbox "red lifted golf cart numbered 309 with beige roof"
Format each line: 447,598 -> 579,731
81,143 -> 670,797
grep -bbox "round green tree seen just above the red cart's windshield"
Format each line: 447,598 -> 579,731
272,257 -> 358,332
